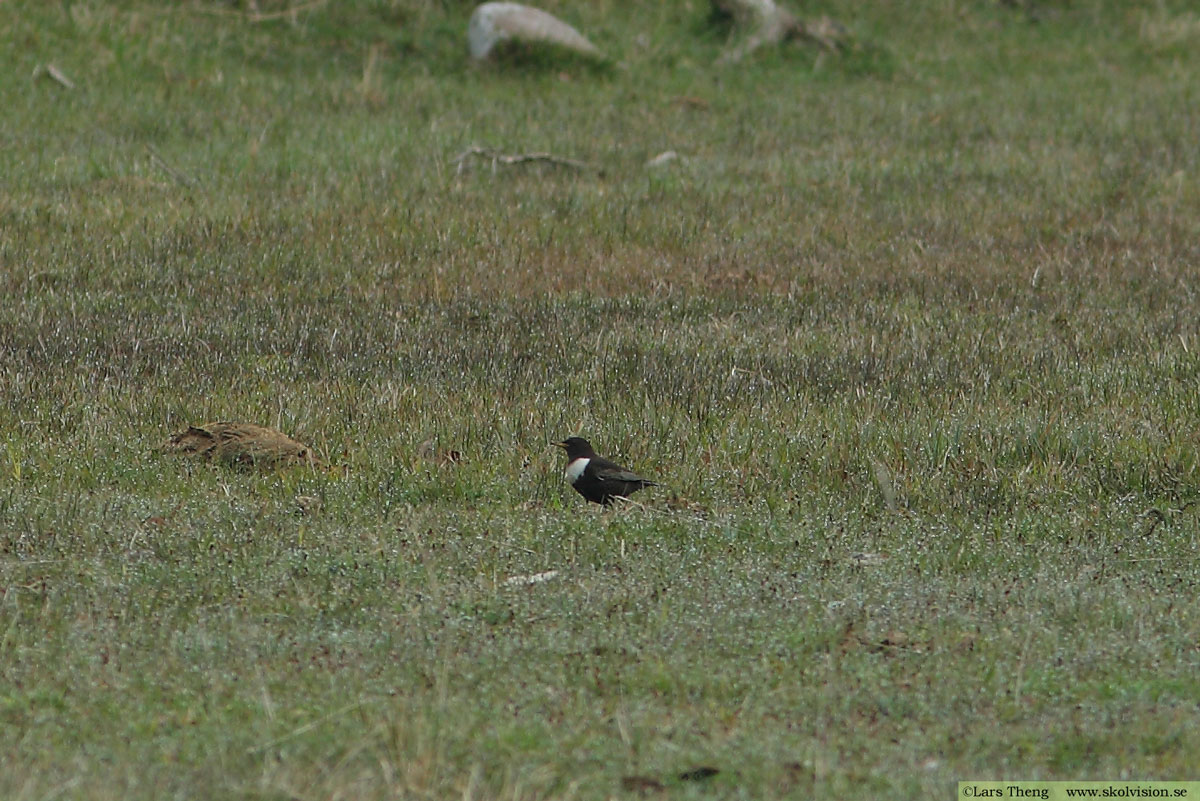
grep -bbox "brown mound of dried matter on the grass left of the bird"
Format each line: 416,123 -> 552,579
166,422 -> 322,468
